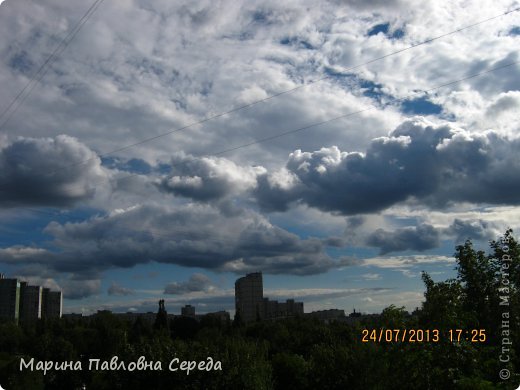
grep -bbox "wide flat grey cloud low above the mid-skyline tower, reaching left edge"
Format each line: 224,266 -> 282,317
0,204 -> 336,278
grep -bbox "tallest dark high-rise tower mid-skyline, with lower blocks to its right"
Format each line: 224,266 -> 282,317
235,272 -> 264,323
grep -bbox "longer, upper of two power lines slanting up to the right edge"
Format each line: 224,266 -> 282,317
21,7 -> 520,172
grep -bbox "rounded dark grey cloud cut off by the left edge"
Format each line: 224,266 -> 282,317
0,135 -> 105,207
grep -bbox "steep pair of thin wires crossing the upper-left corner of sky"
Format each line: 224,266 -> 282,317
0,0 -> 103,131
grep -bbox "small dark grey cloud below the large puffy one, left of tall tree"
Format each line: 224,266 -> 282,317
366,224 -> 440,255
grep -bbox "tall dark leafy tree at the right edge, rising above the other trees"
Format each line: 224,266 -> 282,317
419,229 -> 520,389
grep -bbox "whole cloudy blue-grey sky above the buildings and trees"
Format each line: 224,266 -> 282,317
0,0 -> 520,314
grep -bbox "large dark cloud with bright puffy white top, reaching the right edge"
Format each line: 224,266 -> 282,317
255,118 -> 520,215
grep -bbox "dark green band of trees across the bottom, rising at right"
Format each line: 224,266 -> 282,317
0,231 -> 520,390
